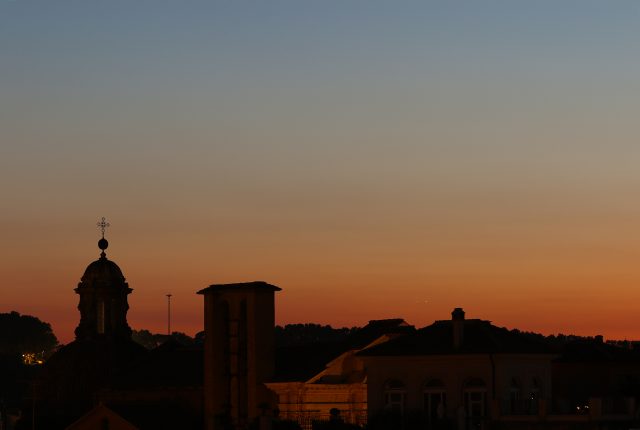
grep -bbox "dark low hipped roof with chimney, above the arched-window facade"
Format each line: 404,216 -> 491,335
358,319 -> 553,356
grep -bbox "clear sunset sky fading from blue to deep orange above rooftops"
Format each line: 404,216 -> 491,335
0,0 -> 640,342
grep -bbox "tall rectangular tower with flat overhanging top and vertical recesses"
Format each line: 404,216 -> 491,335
198,281 -> 280,430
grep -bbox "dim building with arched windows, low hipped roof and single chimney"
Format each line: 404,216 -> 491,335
360,308 -> 556,429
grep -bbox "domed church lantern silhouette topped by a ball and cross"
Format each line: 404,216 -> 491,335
75,217 -> 133,340
